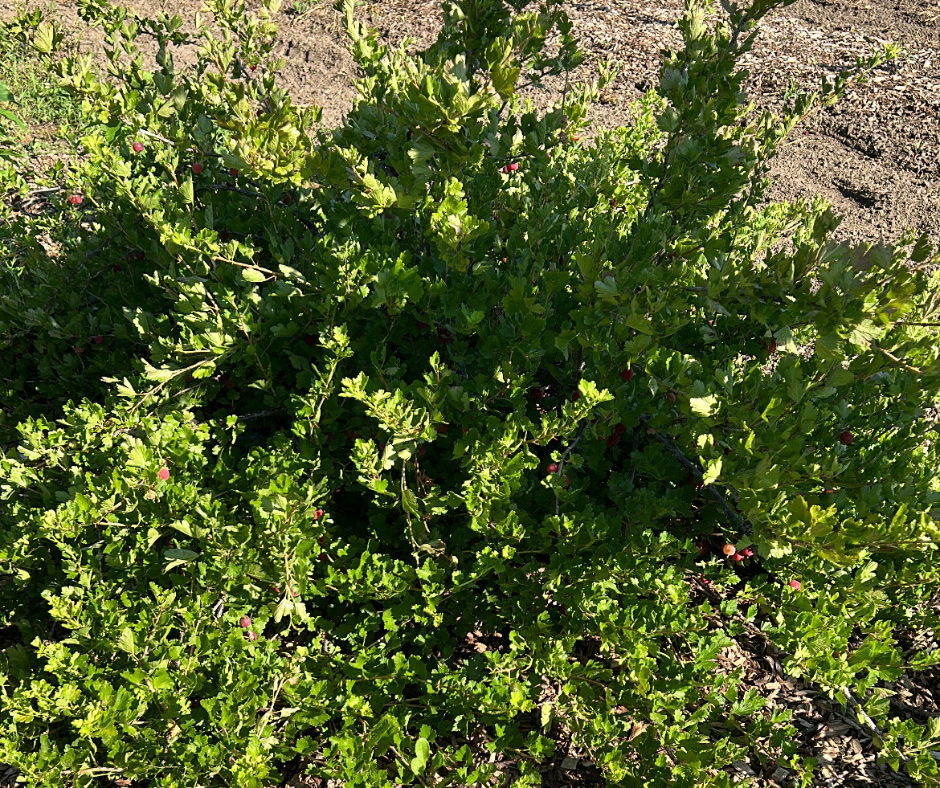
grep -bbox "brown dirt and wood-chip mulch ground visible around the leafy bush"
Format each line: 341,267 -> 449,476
0,0 -> 940,788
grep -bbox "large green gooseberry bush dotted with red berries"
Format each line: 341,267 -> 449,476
0,0 -> 940,788
